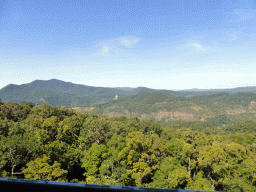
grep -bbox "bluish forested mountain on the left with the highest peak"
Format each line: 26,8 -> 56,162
0,79 -> 132,107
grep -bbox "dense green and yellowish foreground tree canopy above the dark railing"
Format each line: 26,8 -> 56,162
0,102 -> 256,191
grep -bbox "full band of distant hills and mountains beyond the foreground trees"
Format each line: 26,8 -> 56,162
0,79 -> 256,125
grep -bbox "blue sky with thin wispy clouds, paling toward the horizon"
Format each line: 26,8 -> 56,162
0,0 -> 256,90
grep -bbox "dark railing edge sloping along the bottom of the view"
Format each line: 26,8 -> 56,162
0,177 -> 220,192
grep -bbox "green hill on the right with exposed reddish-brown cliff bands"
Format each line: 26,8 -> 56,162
73,92 -> 256,126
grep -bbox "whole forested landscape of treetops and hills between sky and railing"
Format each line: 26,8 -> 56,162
0,80 -> 256,191
